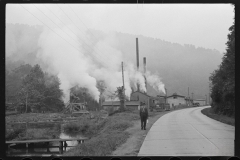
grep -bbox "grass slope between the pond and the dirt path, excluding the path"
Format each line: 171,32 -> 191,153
63,111 -> 139,156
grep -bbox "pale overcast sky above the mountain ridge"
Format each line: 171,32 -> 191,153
6,4 -> 234,53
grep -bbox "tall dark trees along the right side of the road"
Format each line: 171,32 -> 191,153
209,22 -> 235,116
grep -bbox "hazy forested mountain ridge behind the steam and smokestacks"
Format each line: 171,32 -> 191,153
6,24 -> 222,98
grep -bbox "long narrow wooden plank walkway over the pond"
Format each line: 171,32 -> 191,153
5,138 -> 88,144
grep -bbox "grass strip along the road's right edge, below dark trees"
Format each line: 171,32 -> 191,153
201,108 -> 235,126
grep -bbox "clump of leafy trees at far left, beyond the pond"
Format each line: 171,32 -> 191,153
5,64 -> 64,112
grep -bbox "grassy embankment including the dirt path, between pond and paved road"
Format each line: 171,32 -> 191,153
63,106 -> 191,156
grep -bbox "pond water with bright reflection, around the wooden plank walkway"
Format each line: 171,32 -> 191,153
7,129 -> 85,156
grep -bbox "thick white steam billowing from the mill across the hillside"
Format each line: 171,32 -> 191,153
6,25 -> 165,102
